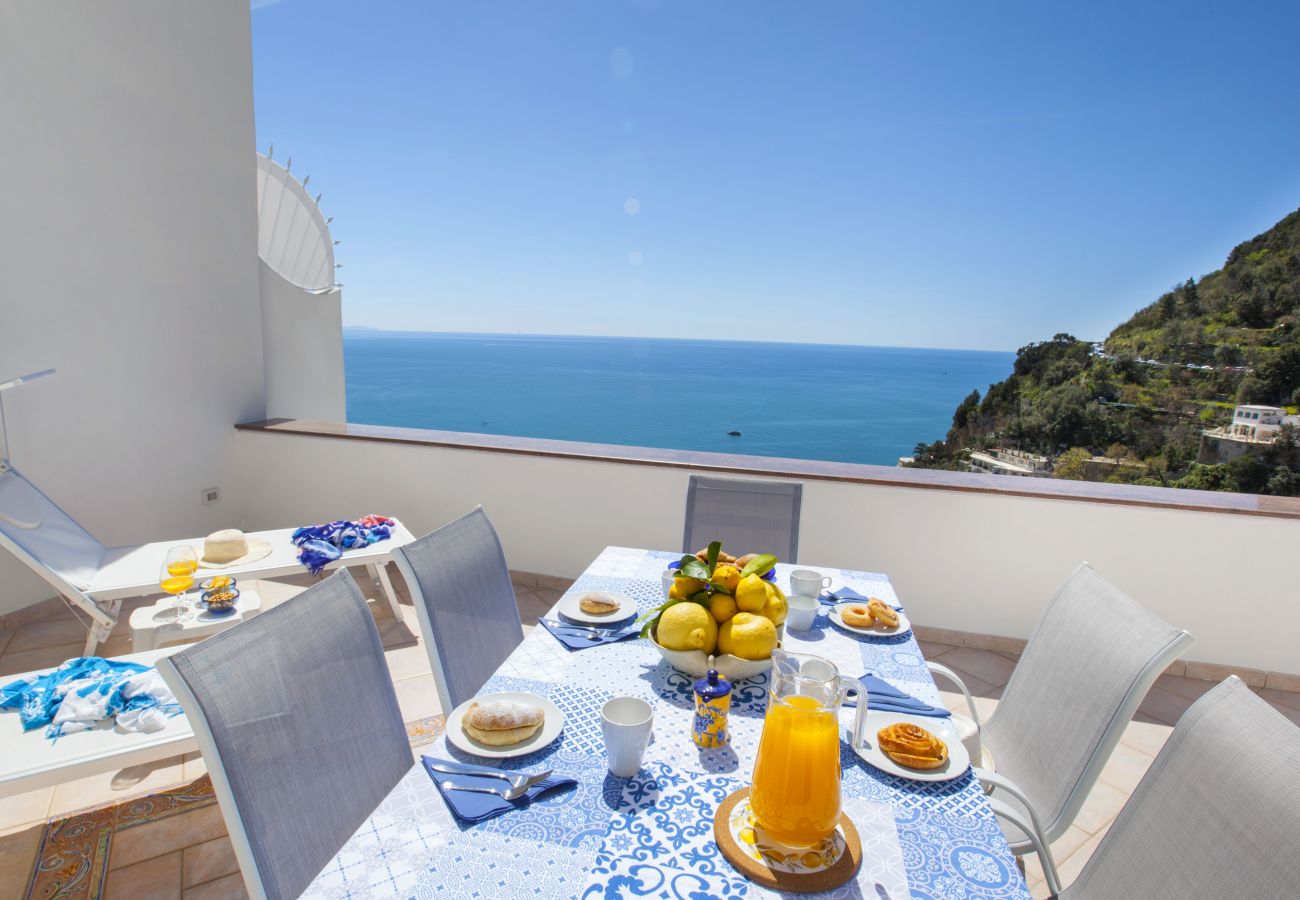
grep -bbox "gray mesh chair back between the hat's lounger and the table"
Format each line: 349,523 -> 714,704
393,506 -> 524,713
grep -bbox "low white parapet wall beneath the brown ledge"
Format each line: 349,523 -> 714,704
239,432 -> 1300,672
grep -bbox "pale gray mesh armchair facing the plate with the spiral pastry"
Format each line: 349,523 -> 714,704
928,563 -> 1192,891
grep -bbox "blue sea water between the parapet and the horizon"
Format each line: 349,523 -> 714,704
343,329 -> 1015,466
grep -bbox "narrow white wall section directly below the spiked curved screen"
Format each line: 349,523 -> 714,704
257,260 -> 347,421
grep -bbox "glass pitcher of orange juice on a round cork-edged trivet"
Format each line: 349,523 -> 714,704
750,649 -> 867,847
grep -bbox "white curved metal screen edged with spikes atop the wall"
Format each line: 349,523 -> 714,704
257,144 -> 342,294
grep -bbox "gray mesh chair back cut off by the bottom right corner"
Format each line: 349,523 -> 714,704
1060,676 -> 1300,900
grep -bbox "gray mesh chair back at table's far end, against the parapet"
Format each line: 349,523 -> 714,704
681,475 -> 803,563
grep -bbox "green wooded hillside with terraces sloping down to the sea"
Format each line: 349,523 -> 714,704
913,211 -> 1300,496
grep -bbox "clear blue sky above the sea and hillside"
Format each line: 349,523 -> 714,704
252,0 -> 1300,350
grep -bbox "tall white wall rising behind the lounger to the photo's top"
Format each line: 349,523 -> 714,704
0,0 -> 265,613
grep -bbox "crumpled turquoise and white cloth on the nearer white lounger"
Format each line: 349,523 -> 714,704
0,657 -> 181,740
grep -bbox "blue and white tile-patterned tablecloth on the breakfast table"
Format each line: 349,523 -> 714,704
304,548 -> 1030,900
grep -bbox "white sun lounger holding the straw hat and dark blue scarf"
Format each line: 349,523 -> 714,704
0,460 -> 411,655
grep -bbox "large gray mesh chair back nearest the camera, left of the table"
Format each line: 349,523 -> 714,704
157,571 -> 412,900
